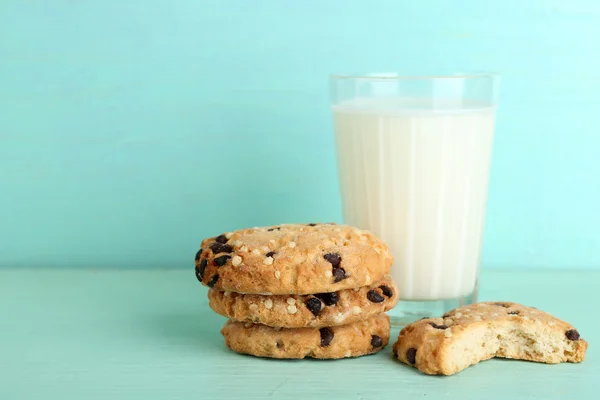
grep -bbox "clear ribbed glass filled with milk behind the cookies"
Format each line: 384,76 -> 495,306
331,73 -> 499,326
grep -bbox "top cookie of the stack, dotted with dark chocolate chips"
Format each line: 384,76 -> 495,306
196,224 -> 392,295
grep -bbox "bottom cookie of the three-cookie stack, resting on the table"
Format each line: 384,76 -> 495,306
221,314 -> 390,358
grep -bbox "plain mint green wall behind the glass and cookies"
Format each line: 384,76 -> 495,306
0,0 -> 600,268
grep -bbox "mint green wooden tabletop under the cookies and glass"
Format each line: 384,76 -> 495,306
0,269 -> 600,400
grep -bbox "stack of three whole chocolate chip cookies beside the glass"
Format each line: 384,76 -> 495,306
196,224 -> 398,358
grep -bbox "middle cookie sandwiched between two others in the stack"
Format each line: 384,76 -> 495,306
208,276 -> 398,328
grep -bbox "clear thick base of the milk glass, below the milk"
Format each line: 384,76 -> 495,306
388,293 -> 477,328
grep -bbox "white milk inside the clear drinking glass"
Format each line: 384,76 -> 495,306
333,99 -> 494,300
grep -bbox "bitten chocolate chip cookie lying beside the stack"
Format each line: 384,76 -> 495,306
394,302 -> 587,375
